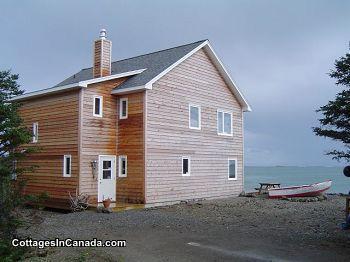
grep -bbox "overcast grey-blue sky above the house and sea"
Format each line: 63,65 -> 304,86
0,0 -> 350,166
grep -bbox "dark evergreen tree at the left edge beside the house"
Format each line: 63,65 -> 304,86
0,71 -> 35,261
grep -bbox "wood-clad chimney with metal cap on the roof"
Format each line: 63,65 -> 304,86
93,29 -> 112,78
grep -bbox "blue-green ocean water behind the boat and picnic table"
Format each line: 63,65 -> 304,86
244,166 -> 350,193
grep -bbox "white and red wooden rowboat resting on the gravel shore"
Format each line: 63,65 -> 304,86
268,180 -> 332,198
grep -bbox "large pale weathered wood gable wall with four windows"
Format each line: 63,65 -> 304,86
146,50 -> 243,204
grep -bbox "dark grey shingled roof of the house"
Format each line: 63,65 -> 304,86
56,40 -> 206,90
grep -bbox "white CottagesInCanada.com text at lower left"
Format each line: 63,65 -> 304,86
12,238 -> 126,249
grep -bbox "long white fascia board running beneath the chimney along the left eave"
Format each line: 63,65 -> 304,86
10,69 -> 146,101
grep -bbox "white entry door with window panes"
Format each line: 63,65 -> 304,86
98,156 -> 116,202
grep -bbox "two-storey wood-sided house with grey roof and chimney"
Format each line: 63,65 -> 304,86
13,30 -> 250,207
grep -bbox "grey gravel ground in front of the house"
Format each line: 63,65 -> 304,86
21,196 -> 350,261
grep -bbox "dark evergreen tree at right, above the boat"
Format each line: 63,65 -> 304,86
313,47 -> 350,162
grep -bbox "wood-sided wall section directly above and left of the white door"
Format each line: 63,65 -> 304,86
80,79 -> 124,204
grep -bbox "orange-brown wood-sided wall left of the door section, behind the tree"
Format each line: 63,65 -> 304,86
18,91 -> 79,205
